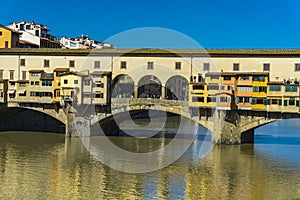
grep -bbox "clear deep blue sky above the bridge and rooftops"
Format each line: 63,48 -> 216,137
0,0 -> 300,48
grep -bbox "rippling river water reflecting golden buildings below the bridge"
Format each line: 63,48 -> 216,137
0,120 -> 300,199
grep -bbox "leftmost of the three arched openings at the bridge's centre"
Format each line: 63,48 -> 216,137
112,74 -> 134,98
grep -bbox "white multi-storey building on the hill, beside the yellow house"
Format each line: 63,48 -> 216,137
7,21 -> 61,48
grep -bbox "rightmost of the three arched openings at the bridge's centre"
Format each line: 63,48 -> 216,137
165,75 -> 189,101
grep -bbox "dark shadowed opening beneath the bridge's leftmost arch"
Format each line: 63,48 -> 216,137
0,108 -> 65,134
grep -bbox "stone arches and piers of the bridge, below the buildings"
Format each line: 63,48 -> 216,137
0,98 -> 299,144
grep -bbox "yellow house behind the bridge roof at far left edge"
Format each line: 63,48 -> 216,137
0,24 -> 22,48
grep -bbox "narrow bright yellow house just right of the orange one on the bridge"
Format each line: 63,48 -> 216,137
252,72 -> 269,110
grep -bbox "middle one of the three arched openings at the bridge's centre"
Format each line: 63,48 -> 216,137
138,75 -> 162,99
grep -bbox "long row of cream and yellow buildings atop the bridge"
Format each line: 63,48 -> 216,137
0,49 -> 300,112
